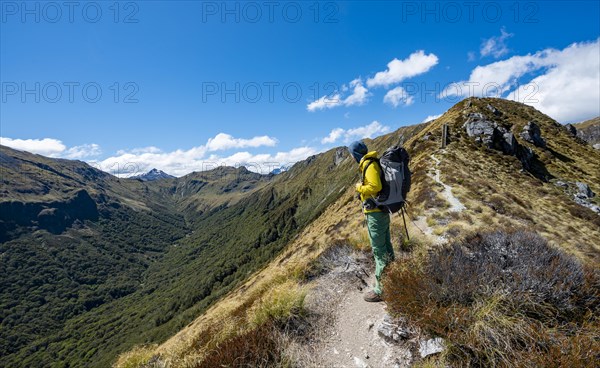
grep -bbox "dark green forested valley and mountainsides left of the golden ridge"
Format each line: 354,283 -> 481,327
0,125 -> 422,367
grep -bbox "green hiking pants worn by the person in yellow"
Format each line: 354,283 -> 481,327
365,212 -> 394,295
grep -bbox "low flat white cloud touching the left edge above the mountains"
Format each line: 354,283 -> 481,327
0,137 -> 102,160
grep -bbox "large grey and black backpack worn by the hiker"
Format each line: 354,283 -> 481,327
363,146 -> 411,213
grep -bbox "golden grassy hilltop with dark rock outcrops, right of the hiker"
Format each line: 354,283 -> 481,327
411,99 -> 600,262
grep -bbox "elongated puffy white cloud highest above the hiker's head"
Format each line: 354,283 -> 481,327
367,50 -> 438,87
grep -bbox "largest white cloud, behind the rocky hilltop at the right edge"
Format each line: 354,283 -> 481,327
441,39 -> 600,122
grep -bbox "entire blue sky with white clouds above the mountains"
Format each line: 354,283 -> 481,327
0,1 -> 600,175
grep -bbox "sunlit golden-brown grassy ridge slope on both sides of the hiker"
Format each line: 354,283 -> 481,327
117,98 -> 600,367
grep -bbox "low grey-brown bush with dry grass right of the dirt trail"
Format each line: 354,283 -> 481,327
384,231 -> 600,367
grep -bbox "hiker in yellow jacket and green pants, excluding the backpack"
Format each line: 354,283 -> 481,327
348,141 -> 394,302
